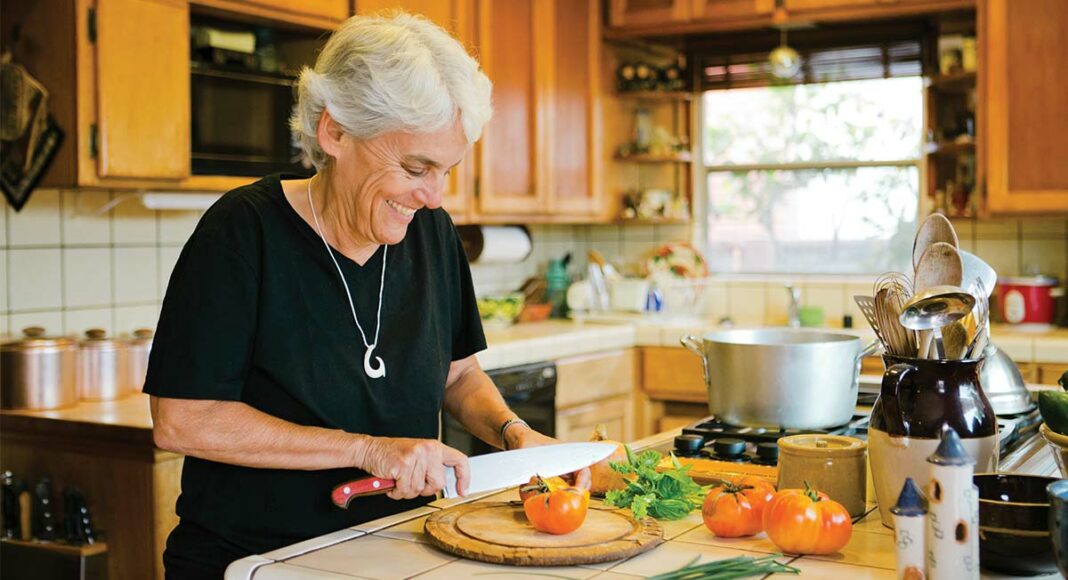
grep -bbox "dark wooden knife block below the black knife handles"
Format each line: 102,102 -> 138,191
0,539 -> 108,580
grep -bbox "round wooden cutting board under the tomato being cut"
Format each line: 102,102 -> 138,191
425,502 -> 663,566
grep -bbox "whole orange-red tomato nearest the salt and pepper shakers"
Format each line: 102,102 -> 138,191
764,485 -> 853,554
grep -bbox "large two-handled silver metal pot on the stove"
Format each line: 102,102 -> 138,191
681,328 -> 879,429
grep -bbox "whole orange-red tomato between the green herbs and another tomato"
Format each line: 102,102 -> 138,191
701,476 -> 775,537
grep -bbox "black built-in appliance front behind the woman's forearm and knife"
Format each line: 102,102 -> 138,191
441,362 -> 556,456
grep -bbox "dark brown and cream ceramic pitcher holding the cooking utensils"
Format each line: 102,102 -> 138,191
868,355 -> 998,528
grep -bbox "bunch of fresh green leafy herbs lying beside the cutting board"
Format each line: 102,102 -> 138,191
604,446 -> 708,519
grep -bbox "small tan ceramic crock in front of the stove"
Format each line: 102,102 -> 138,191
779,434 -> 867,517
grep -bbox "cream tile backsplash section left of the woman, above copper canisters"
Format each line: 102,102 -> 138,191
0,189 -> 201,335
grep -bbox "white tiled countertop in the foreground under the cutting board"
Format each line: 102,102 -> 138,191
226,429 -> 1059,580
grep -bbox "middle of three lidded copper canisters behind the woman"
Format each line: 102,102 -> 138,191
78,328 -> 134,401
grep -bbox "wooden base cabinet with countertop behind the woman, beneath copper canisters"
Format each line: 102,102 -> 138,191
0,393 -> 184,580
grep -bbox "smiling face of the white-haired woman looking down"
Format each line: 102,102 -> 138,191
331,117 -> 468,245
